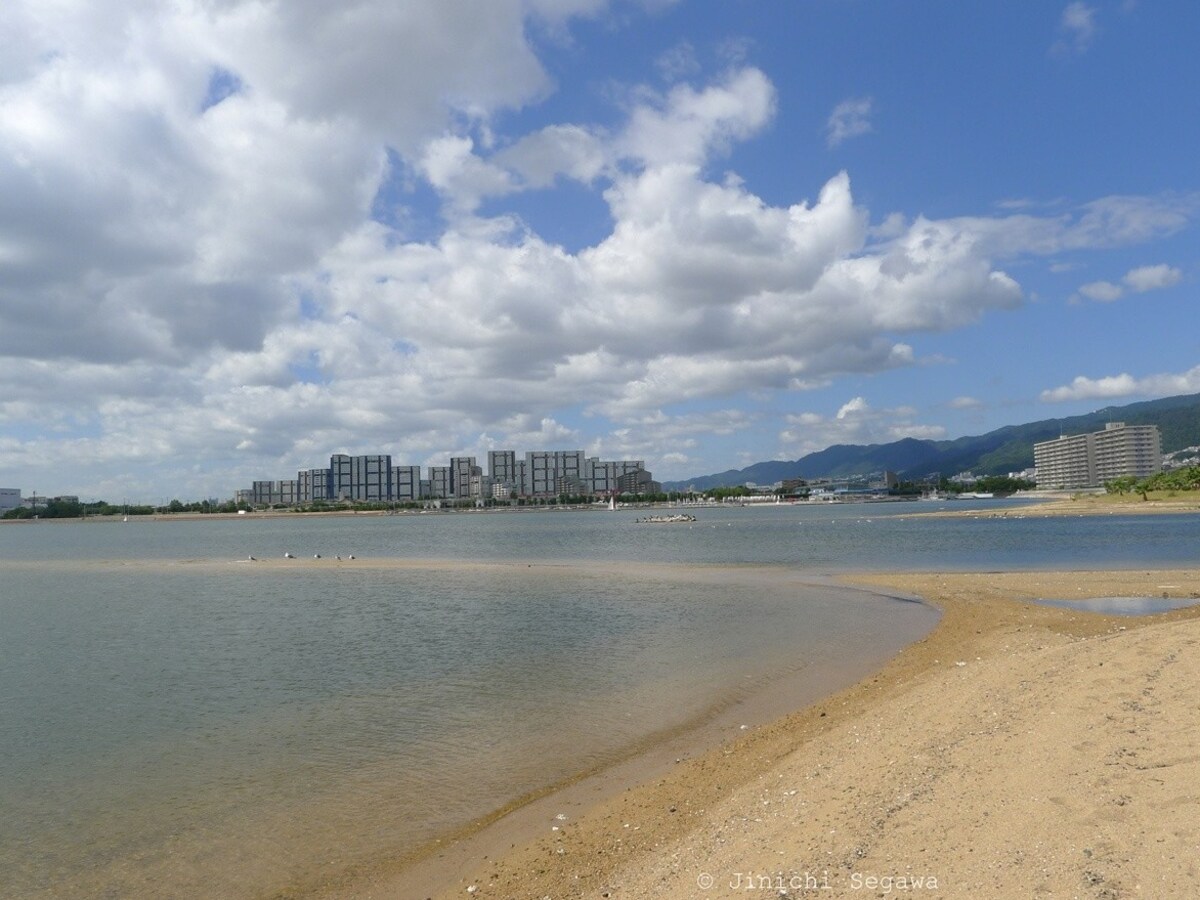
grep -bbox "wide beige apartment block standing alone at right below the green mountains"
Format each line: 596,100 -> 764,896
1033,422 -> 1163,491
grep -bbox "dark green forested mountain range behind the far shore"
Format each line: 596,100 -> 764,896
662,394 -> 1200,491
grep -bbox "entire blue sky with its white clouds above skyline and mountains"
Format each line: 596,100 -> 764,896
0,0 -> 1200,500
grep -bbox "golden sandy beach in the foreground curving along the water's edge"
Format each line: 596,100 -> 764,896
348,569 -> 1200,900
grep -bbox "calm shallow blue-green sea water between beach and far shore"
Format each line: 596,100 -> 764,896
0,504 -> 1200,898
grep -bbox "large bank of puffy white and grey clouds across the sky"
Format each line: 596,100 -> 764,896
0,0 -> 1194,496
